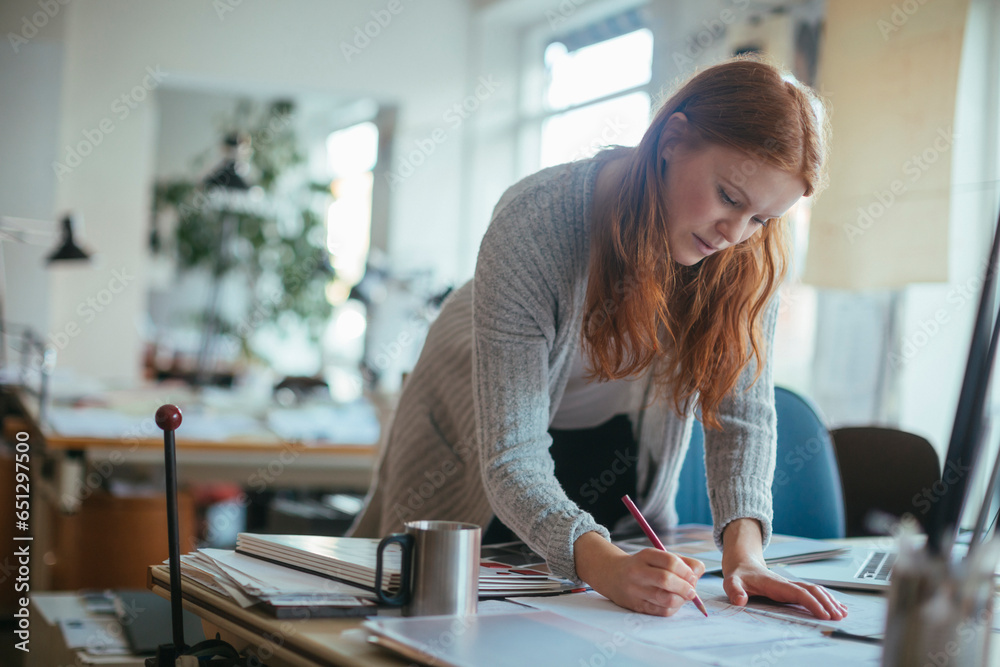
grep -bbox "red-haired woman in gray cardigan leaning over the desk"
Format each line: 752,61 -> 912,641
353,59 -> 846,619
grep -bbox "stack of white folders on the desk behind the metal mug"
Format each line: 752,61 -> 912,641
236,533 -> 576,598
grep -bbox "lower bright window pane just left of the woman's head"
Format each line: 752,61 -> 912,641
540,93 -> 649,167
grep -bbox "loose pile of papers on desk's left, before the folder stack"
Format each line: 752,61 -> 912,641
172,549 -> 375,618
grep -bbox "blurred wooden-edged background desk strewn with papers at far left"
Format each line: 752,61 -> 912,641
5,388 -> 377,590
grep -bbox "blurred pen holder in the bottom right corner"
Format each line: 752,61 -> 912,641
882,544 -> 997,667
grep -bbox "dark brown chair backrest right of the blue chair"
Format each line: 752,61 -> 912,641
831,426 -> 943,537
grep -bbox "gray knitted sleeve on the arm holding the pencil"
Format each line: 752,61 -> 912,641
472,185 -> 608,581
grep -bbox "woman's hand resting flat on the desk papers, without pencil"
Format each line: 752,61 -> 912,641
723,559 -> 847,621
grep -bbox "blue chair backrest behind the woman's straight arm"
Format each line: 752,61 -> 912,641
677,387 -> 845,539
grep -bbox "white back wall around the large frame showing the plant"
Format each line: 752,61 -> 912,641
11,0 -> 468,379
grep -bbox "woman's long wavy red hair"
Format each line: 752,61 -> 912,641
583,58 -> 828,428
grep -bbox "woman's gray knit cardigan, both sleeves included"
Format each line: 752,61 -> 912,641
352,160 -> 777,580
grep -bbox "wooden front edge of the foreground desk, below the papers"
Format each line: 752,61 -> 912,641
146,565 -> 405,667
